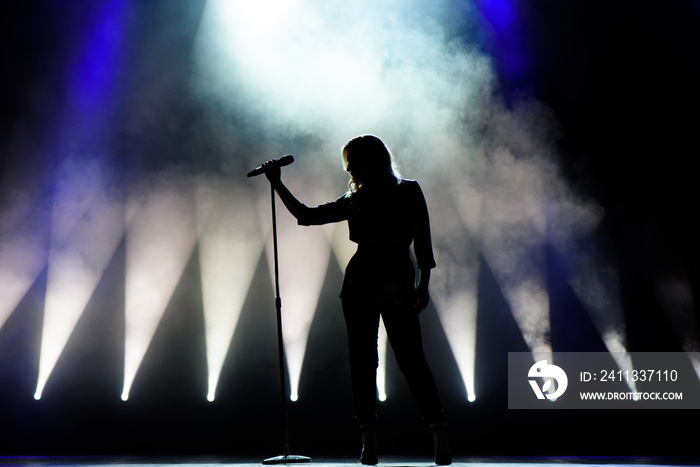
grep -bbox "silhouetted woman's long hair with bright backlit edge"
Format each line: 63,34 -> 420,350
342,135 -> 400,193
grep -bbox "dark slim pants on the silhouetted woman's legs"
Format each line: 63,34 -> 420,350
343,299 -> 443,425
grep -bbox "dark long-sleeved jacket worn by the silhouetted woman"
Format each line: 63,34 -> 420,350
298,179 -> 435,305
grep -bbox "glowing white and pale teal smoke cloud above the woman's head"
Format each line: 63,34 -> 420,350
194,0 -> 494,164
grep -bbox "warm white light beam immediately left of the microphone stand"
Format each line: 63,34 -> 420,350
195,177 -> 263,401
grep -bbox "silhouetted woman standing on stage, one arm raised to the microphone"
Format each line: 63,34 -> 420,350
264,135 -> 452,465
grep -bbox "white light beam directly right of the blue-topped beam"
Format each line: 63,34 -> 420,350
122,173 -> 197,400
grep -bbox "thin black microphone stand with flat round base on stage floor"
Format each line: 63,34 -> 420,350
263,184 -> 311,464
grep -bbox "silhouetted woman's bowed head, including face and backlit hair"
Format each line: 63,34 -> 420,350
342,135 -> 398,192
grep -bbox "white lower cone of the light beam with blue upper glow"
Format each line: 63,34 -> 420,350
37,163 -> 124,396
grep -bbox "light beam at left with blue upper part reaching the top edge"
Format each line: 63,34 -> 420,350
35,0 -> 128,399
